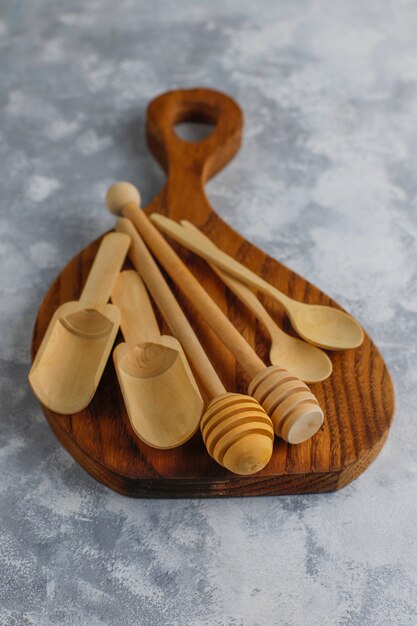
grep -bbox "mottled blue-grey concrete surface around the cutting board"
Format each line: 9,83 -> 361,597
0,0 -> 417,626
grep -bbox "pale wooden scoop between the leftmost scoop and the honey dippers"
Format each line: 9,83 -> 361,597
112,270 -> 203,449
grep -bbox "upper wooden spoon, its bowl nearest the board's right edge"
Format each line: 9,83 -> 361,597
151,213 -> 364,350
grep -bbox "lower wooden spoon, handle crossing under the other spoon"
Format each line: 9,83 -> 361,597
181,220 -> 332,383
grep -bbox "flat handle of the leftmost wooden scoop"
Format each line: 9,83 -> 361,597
79,233 -> 130,309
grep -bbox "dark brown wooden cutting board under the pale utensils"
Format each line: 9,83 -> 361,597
32,89 -> 394,497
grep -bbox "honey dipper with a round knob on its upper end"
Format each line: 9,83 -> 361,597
107,183 -> 323,443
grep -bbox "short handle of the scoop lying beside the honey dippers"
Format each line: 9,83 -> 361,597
111,270 -> 161,346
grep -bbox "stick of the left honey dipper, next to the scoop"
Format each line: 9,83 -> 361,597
116,218 -> 225,397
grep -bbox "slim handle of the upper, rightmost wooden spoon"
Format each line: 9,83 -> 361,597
150,213 -> 292,311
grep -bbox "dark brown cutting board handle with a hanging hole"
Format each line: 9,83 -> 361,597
146,88 -> 243,223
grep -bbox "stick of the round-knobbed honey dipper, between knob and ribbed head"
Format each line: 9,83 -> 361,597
118,202 -> 265,378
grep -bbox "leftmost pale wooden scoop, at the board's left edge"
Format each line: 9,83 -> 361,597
29,233 -> 130,415
